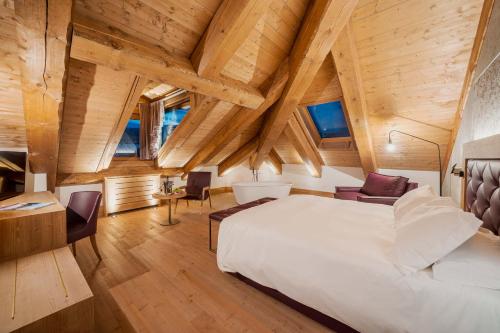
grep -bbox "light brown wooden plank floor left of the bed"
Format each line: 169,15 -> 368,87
73,193 -> 330,333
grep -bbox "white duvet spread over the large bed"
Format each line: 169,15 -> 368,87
217,195 -> 500,333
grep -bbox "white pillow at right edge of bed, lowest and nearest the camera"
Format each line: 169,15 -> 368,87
432,232 -> 500,289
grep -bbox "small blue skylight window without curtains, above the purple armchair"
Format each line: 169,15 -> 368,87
307,101 -> 351,139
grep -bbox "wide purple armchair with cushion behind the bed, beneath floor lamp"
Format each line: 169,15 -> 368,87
333,173 -> 418,206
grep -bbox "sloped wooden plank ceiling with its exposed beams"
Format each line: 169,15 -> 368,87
0,0 -> 483,185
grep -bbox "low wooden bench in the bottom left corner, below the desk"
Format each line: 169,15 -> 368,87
0,246 -> 94,333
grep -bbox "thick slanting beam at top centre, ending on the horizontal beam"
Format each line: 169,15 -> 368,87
191,0 -> 272,77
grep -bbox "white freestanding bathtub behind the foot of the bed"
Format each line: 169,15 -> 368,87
233,182 -> 292,205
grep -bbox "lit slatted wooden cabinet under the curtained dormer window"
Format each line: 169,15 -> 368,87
104,175 -> 160,214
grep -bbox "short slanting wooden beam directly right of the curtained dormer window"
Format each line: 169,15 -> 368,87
158,94 -> 219,167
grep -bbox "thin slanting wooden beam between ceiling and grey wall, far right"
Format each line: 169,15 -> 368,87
441,0 -> 495,181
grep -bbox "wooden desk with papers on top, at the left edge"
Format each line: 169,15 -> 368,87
0,191 -> 66,262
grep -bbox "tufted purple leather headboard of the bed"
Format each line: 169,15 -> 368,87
464,159 -> 500,235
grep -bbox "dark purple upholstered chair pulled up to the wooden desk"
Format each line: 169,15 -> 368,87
66,191 -> 102,260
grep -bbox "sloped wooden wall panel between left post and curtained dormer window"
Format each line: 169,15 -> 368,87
58,59 -> 141,174
